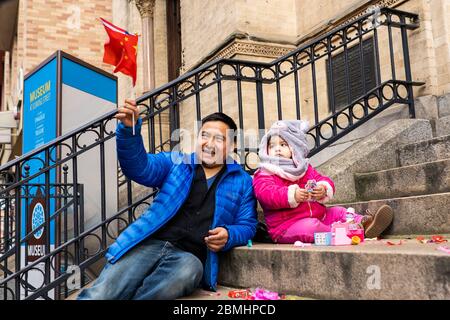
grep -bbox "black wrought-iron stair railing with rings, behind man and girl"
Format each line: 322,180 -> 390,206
0,9 -> 421,299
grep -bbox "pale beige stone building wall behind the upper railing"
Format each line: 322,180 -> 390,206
176,0 -> 450,162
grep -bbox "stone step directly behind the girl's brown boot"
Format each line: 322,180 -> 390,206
333,192 -> 450,235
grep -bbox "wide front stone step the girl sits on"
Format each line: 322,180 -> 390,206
219,240 -> 450,299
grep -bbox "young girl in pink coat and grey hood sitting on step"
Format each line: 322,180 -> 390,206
253,120 -> 393,243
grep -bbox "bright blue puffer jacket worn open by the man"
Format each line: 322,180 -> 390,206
106,120 -> 257,291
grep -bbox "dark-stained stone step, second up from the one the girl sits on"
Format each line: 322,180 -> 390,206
355,159 -> 450,201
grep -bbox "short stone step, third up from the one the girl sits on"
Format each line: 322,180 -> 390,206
398,135 -> 450,166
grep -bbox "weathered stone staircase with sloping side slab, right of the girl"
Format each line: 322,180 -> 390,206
219,102 -> 450,299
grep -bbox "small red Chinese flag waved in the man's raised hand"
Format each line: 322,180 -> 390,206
100,18 -> 138,86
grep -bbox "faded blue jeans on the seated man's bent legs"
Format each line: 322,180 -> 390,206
77,239 -> 203,300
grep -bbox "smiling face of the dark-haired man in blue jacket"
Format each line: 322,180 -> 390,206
196,121 -> 233,168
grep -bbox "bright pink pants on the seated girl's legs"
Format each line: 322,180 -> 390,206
277,207 -> 362,243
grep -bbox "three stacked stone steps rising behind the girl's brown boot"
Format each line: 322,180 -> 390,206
347,131 -> 450,235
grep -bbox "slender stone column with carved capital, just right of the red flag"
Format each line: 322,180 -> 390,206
135,0 -> 155,92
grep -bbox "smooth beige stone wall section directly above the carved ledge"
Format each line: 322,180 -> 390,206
181,0 -> 297,70
